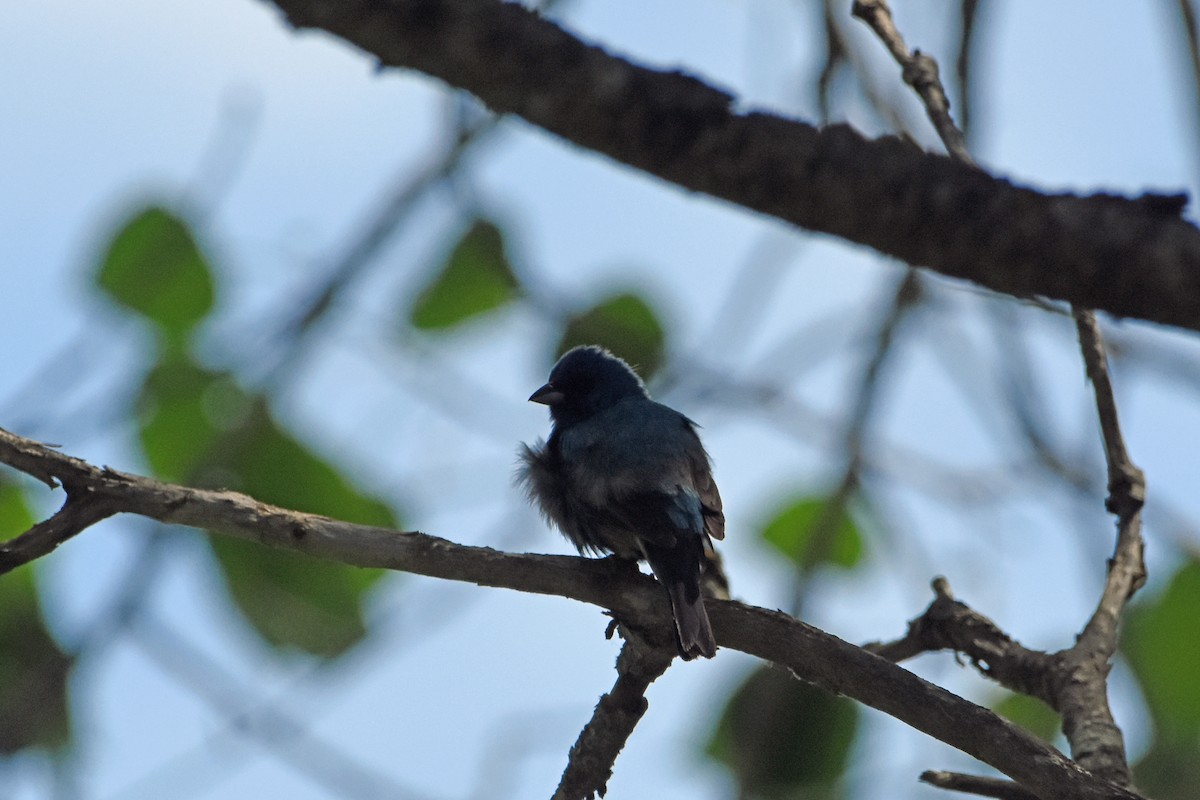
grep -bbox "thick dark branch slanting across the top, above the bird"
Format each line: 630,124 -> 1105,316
260,0 -> 1200,330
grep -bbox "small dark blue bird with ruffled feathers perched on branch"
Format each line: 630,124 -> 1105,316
517,344 -> 725,661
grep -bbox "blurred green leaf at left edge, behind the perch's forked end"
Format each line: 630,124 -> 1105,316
0,481 -> 72,756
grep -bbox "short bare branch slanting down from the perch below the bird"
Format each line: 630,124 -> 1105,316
551,628 -> 677,800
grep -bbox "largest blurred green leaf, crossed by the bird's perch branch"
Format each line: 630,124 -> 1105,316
140,353 -> 396,657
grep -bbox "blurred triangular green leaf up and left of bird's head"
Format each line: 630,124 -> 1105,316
409,219 -> 518,330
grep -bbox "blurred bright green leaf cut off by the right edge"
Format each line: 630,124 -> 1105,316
1122,560 -> 1200,743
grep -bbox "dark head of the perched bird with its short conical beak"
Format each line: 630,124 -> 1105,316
529,344 -> 647,425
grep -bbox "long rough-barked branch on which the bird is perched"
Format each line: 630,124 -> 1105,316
0,429 -> 1139,800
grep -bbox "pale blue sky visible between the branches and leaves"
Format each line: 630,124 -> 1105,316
0,0 -> 1200,800
